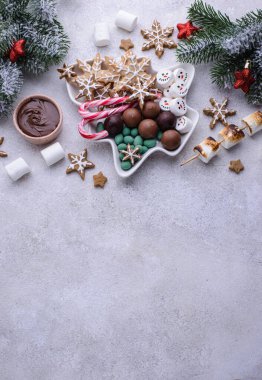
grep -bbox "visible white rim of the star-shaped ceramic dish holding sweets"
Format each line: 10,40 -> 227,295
66,61 -> 199,178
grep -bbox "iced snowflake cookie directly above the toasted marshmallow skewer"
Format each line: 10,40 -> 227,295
203,98 -> 236,129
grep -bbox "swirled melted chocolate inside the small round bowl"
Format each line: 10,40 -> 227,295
17,98 -> 60,137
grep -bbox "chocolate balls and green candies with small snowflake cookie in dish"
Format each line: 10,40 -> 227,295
96,101 -> 181,170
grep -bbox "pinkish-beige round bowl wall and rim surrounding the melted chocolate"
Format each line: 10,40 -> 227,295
13,94 -> 63,145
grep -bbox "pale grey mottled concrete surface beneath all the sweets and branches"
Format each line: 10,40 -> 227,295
0,0 -> 262,380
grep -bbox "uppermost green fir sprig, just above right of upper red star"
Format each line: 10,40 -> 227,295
188,0 -> 233,33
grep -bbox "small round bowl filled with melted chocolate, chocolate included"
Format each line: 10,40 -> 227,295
14,95 -> 63,145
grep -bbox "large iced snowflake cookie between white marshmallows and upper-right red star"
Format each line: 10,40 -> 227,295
141,20 -> 177,58
